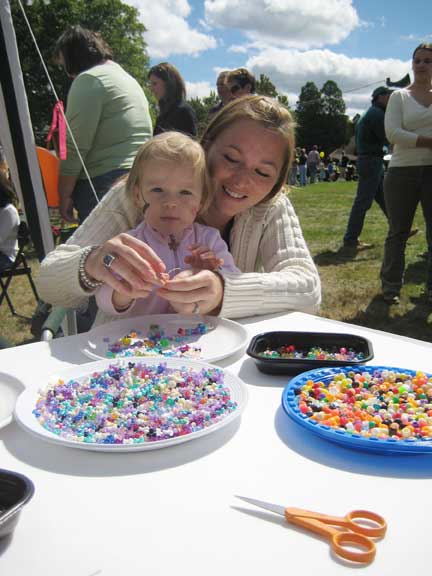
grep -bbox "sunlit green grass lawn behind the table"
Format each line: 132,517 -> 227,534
0,182 -> 432,344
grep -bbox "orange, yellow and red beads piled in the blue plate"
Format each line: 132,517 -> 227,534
296,369 -> 432,440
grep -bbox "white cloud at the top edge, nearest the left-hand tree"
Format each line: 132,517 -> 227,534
128,0 -> 217,58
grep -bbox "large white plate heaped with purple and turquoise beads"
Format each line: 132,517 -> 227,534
15,358 -> 247,452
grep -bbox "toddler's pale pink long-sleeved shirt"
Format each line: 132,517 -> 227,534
96,222 -> 240,317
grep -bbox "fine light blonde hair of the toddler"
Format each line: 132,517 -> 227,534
126,132 -> 211,214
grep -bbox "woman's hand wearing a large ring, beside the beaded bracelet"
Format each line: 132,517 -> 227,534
85,234 -> 167,298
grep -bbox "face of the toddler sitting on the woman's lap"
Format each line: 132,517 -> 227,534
135,160 -> 202,240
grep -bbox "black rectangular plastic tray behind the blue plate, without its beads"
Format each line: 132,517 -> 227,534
246,331 -> 373,374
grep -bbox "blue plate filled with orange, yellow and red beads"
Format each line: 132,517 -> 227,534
282,366 -> 432,454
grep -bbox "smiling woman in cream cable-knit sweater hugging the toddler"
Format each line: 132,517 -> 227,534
39,96 -> 321,323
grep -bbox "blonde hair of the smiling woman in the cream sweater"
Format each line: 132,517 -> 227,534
201,96 -> 295,200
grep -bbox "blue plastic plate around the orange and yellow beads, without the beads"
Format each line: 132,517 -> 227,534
282,366 -> 432,454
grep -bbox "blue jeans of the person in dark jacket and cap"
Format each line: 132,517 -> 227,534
344,156 -> 387,245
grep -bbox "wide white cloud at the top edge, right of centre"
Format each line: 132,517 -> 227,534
204,0 -> 360,49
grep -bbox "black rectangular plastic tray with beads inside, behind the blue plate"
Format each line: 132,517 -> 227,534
246,331 -> 373,374
